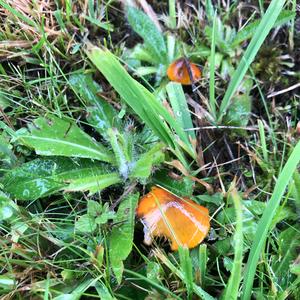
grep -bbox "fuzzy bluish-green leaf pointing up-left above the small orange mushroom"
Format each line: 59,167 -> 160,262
127,6 -> 167,64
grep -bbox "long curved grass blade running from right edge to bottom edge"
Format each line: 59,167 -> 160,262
242,142 -> 300,300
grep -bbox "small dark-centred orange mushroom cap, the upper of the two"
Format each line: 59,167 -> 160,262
167,58 -> 201,85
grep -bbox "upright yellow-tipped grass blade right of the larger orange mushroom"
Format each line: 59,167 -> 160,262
223,188 -> 244,300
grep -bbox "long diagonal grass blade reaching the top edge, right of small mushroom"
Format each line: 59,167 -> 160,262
218,0 -> 285,123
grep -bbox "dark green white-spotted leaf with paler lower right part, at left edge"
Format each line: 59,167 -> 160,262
2,157 -> 120,200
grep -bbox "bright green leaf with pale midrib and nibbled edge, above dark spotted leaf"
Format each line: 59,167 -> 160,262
17,116 -> 113,162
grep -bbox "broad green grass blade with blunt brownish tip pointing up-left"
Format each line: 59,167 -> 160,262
87,47 -> 195,158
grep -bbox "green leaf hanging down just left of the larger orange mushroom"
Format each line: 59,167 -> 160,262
109,194 -> 139,284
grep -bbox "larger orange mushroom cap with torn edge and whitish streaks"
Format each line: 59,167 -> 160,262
137,187 -> 210,251
